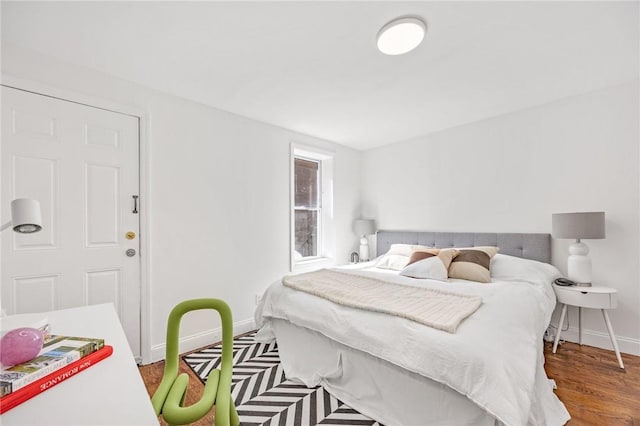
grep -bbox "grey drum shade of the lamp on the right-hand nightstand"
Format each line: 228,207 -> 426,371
551,212 -> 605,240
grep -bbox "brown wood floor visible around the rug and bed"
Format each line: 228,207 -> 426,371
140,342 -> 640,426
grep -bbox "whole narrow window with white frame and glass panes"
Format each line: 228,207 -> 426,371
291,144 -> 335,270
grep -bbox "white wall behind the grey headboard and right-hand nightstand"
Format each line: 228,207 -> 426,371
362,81 -> 640,354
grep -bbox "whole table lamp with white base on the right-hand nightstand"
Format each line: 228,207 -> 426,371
551,212 -> 605,286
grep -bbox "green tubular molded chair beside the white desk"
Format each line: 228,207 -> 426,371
151,299 -> 240,426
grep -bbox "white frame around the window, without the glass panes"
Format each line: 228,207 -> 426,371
289,142 -> 335,272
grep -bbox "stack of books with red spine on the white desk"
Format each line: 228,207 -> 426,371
0,335 -> 113,414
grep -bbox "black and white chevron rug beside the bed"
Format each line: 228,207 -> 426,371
183,333 -> 382,426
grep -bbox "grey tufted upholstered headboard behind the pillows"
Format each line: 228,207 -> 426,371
376,231 -> 551,263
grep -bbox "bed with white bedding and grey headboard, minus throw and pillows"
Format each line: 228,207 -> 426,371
256,231 -> 570,426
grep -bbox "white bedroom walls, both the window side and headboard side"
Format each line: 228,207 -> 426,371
2,45 -> 640,358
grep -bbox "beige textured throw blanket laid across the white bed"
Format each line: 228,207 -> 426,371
282,269 -> 482,333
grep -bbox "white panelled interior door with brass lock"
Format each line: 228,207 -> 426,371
0,87 -> 140,356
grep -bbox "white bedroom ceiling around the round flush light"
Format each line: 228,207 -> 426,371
2,1 -> 639,149
